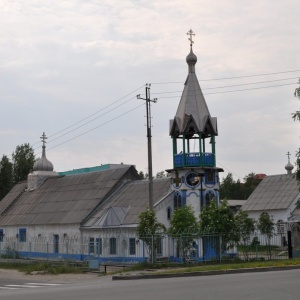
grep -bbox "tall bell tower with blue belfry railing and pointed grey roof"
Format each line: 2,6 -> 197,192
167,30 -> 223,216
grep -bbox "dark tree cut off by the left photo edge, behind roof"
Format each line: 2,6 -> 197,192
0,155 -> 13,200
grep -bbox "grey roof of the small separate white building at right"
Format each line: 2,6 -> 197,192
242,174 -> 300,211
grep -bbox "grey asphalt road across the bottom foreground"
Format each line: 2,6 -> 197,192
0,270 -> 300,300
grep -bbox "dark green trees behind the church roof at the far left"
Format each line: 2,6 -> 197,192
0,143 -> 35,200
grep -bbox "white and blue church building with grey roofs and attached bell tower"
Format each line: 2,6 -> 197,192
0,30 -> 223,261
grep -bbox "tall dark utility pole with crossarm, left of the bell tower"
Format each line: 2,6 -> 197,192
137,84 -> 157,210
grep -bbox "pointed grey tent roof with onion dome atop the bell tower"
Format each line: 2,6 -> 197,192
170,38 -> 218,136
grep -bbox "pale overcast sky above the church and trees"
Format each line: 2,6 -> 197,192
0,0 -> 300,179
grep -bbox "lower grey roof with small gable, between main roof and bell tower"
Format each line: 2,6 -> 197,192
83,178 -> 172,227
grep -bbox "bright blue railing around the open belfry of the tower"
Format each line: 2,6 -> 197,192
174,152 -> 215,168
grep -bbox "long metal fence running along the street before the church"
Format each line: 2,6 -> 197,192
0,225 -> 300,263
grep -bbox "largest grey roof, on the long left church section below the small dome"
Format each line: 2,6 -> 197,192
0,167 -> 139,226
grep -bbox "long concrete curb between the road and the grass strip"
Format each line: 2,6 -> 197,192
112,265 -> 300,280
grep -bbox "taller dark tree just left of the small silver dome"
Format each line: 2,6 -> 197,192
12,143 -> 35,183
